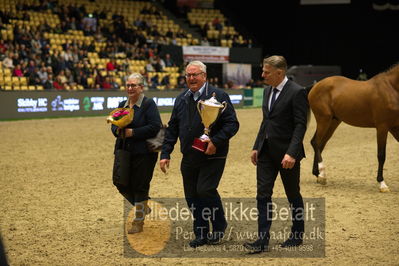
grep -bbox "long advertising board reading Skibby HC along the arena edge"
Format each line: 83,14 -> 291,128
0,90 -> 244,120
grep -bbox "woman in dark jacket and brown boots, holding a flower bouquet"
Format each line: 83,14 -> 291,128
111,73 -> 162,234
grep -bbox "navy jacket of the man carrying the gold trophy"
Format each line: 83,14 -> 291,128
160,86 -> 239,160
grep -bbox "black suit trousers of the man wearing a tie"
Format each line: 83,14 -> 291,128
256,140 -> 304,240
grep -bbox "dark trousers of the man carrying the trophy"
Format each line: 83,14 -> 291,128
180,152 -> 227,237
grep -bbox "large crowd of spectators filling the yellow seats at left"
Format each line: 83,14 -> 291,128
0,1 -> 191,90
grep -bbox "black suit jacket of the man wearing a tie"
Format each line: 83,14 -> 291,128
253,80 -> 309,160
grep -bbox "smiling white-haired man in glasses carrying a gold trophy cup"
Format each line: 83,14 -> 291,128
160,61 -> 239,248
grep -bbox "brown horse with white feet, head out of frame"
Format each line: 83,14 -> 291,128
307,64 -> 399,192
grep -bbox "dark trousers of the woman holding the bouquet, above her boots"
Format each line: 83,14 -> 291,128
117,152 -> 158,205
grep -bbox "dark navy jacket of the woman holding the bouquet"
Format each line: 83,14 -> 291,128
111,96 -> 162,154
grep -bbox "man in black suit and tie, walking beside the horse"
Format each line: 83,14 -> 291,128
244,55 -> 309,253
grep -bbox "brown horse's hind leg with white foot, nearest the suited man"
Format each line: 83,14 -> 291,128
310,118 -> 341,185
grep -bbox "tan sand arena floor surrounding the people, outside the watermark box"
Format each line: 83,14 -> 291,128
0,109 -> 399,265
